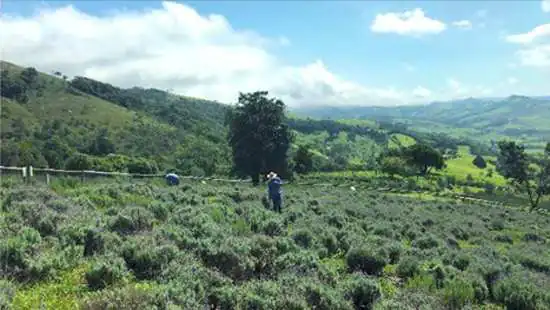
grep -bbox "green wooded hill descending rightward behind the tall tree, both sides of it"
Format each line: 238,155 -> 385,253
1,62 -> 494,175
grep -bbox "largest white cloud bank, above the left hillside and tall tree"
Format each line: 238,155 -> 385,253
0,2 -> 414,105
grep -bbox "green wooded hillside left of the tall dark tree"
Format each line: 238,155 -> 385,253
1,62 -> 230,174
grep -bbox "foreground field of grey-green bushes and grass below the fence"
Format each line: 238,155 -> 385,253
0,180 -> 550,309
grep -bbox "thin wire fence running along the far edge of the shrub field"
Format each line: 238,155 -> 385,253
0,166 -> 516,207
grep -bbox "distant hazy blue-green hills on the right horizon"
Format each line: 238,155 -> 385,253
292,96 -> 550,149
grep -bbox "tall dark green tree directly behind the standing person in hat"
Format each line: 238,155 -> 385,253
227,91 -> 292,185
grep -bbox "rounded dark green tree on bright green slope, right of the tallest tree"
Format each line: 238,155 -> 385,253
403,143 -> 445,176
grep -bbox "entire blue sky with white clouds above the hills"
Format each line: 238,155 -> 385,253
0,0 -> 550,107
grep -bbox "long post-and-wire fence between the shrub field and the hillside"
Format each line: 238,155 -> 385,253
0,166 -> 520,211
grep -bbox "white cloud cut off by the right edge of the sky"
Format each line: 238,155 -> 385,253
506,23 -> 550,68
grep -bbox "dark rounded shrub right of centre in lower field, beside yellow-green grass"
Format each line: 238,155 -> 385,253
346,246 -> 387,275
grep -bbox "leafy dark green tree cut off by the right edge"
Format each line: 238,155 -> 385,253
497,141 -> 550,210
